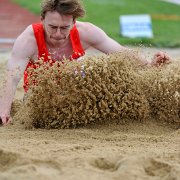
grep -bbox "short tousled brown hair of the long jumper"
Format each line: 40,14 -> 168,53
41,0 -> 85,19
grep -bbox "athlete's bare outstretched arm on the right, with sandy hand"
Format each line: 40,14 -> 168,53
77,22 -> 170,66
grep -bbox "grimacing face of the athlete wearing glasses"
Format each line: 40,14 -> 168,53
42,11 -> 74,45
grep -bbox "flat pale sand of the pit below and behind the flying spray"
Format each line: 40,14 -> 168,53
0,48 -> 180,180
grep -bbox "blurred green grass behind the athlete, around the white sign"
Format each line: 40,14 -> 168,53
13,0 -> 180,47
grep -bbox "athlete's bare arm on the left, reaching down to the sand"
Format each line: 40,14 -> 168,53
0,27 -> 36,124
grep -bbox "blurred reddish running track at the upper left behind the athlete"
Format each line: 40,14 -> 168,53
0,0 -> 40,48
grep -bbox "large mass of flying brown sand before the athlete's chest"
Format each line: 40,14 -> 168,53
15,53 -> 149,129
